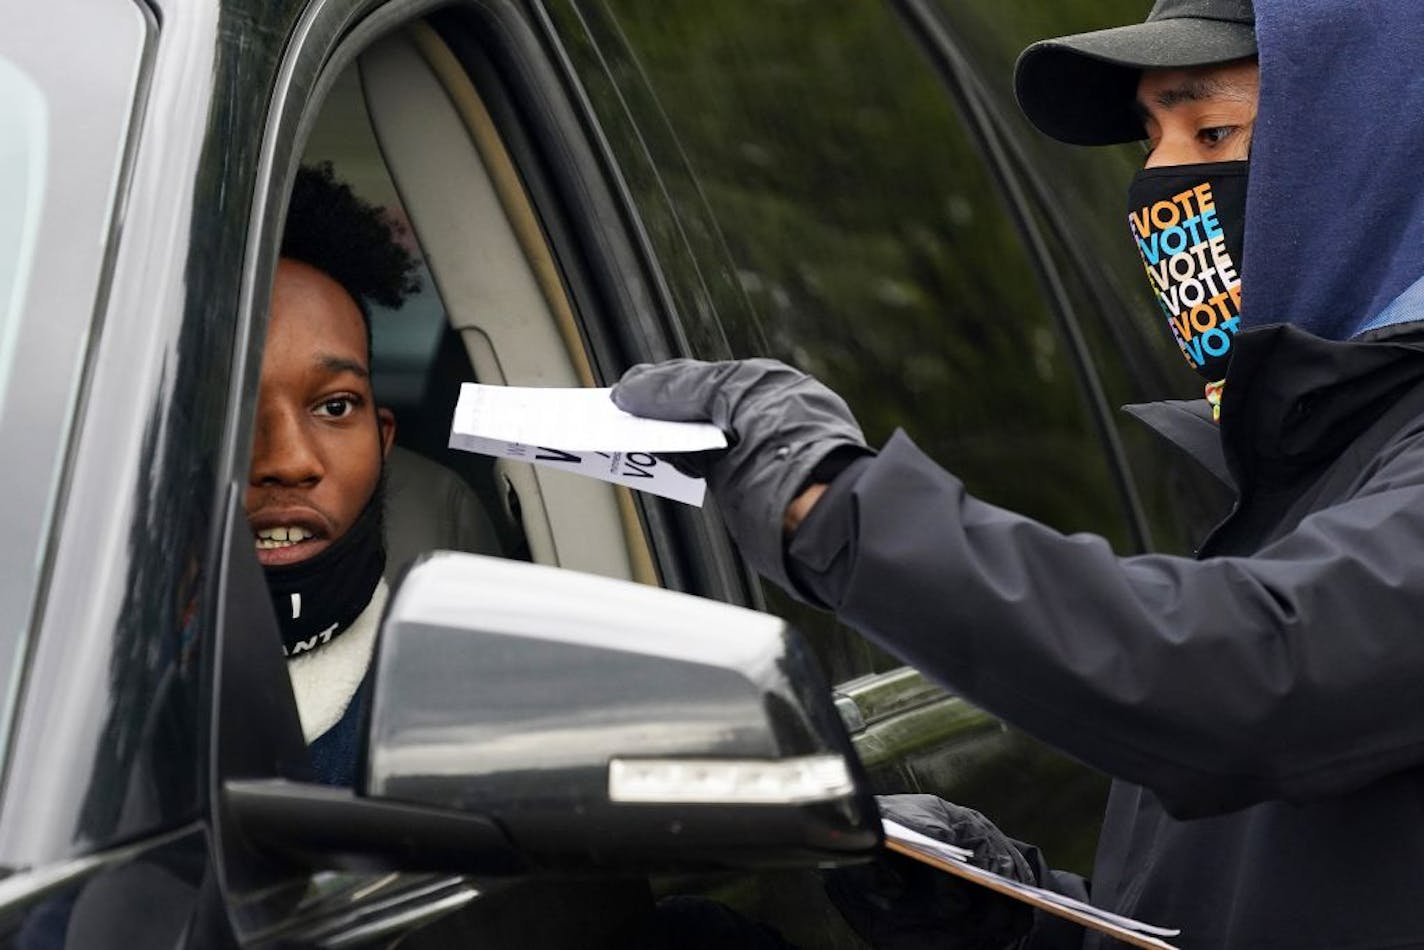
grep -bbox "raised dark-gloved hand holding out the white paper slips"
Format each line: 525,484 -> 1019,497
612,359 -> 869,588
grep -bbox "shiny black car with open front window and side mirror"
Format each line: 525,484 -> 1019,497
0,0 -> 1219,947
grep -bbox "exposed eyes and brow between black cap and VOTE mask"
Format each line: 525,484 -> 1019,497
1136,60 -> 1260,168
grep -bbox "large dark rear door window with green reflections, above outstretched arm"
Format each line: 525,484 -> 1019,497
552,0 -> 1129,679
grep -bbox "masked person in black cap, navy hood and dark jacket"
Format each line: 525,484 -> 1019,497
614,0 -> 1424,950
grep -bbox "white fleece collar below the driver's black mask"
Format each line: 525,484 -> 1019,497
286,580 -> 390,745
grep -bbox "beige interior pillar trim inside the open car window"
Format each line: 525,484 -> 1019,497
347,23 -> 656,583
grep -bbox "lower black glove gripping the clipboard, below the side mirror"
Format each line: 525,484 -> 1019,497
824,795 -> 1038,950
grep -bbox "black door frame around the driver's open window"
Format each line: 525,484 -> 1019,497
211,0 -> 750,946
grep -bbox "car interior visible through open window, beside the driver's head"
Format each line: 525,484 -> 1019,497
302,21 -> 658,584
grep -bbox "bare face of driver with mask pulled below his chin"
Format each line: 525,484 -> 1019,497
246,258 -> 396,565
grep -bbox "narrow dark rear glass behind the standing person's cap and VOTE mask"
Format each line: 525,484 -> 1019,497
937,0 -> 1227,554
